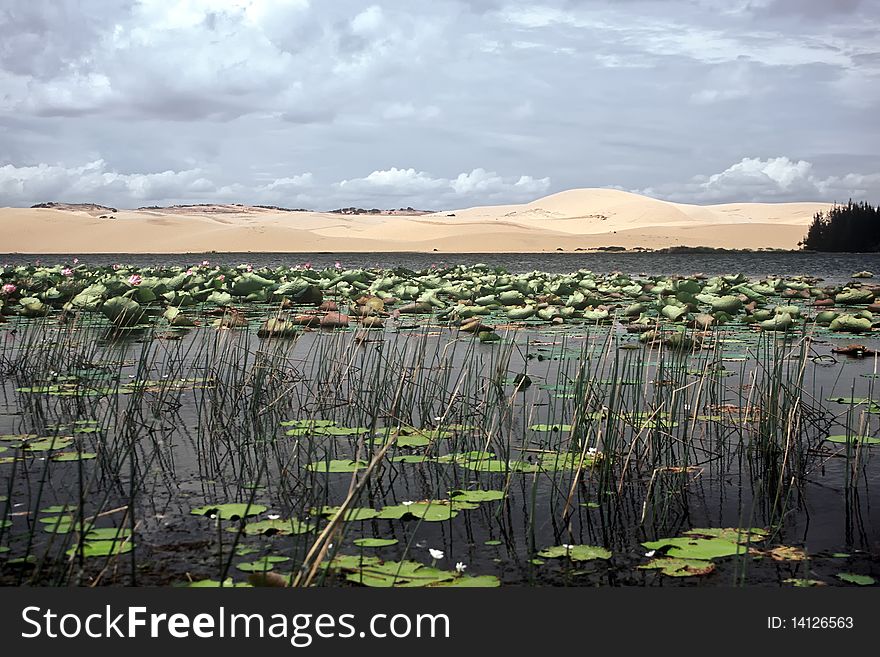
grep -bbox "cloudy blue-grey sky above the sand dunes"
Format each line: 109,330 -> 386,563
0,0 -> 880,210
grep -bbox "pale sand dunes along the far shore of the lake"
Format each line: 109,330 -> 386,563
0,189 -> 831,254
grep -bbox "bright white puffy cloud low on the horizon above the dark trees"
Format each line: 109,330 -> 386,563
633,157 -> 880,203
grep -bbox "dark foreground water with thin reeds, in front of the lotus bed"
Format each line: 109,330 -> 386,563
0,313 -> 880,586
